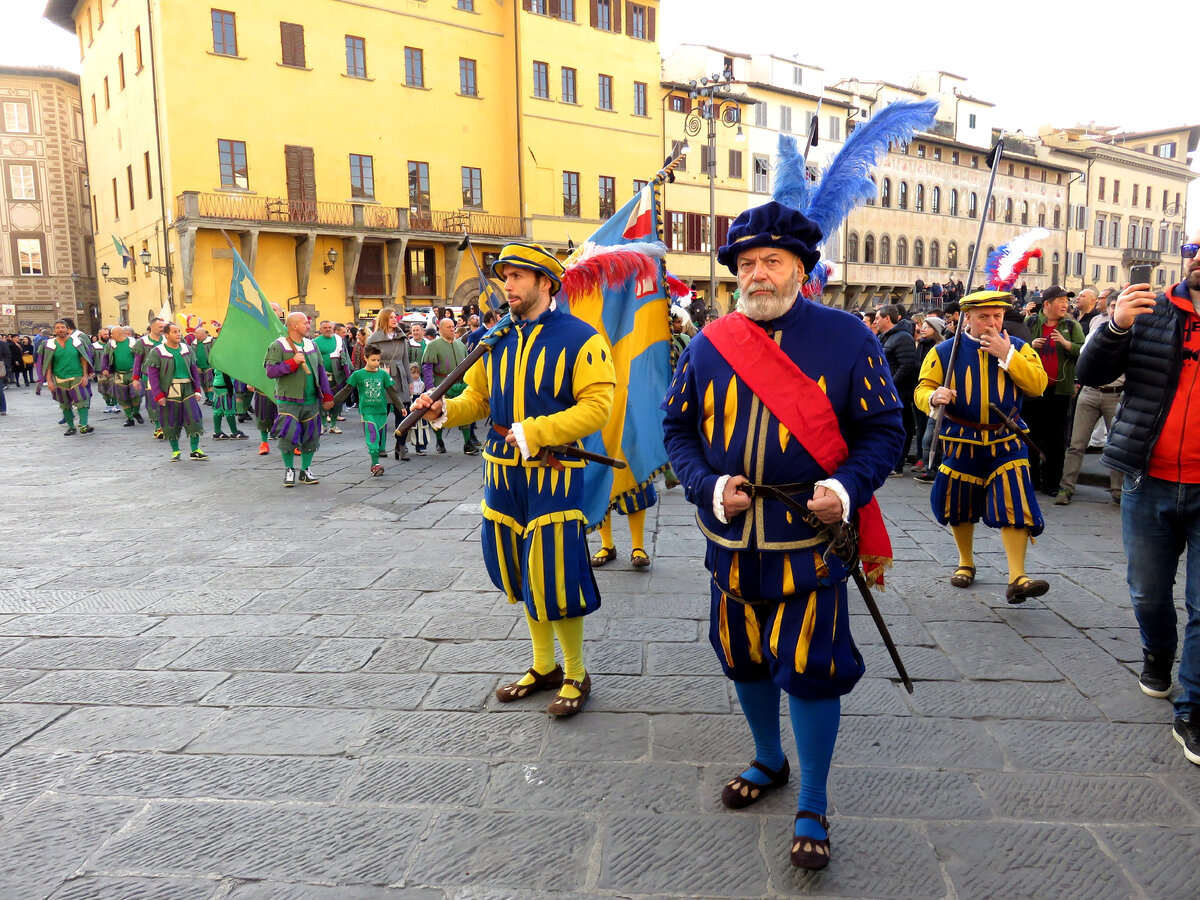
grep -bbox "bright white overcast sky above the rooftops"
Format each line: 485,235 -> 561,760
0,0 -> 1200,228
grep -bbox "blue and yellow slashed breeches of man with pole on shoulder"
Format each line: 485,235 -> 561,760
481,458 -> 600,622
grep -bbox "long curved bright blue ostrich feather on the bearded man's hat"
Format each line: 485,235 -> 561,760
801,100 -> 937,235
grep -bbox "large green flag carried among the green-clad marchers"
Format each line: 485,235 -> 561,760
209,245 -> 287,396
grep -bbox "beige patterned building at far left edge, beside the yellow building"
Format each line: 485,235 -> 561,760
0,66 -> 100,335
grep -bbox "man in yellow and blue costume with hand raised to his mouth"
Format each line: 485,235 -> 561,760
914,290 -> 1049,602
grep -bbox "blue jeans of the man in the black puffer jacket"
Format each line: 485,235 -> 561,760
1121,475 -> 1200,716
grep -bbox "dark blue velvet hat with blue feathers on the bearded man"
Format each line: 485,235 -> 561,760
716,100 -> 938,296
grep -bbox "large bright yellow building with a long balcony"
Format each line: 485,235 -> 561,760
46,0 -> 662,325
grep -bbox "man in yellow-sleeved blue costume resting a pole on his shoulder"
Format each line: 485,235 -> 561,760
413,244 -> 616,716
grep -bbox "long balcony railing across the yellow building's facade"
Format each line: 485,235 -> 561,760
175,191 -> 522,238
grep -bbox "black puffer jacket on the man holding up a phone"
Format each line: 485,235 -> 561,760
1075,294 -> 1187,478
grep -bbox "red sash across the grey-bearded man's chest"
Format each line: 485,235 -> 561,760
704,312 -> 892,587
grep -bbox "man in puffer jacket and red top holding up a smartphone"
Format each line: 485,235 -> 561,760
1078,229 -> 1200,766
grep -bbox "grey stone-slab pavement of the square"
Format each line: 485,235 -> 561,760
0,389 -> 1200,900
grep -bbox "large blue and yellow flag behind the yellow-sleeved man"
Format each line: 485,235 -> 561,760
568,181 -> 671,528
